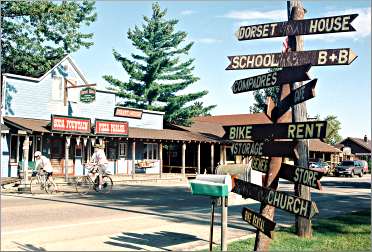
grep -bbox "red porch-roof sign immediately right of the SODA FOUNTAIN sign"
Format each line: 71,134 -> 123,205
94,119 -> 129,136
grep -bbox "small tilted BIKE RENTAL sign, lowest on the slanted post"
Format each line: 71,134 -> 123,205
242,207 -> 276,239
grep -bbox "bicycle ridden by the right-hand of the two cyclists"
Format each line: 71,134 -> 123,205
75,164 -> 113,195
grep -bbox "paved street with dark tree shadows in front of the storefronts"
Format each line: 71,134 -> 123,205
1,176 -> 371,251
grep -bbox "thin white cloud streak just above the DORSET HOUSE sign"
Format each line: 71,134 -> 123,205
223,10 -> 287,22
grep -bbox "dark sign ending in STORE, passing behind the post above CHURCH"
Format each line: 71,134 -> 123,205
251,157 -> 324,190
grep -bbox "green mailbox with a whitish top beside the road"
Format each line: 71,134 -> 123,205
190,174 -> 232,197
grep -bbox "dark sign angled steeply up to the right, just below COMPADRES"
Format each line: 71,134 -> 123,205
266,79 -> 318,122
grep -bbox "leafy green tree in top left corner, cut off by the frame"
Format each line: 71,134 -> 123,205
1,0 -> 97,77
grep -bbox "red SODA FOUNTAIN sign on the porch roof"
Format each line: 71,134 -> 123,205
51,115 -> 91,133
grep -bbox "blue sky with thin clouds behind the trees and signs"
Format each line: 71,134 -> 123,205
72,0 -> 371,138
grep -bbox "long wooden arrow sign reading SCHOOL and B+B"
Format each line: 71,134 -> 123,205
226,48 -> 357,70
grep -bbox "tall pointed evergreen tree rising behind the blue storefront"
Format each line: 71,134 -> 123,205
103,3 -> 215,125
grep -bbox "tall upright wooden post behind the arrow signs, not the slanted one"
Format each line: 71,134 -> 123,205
288,0 -> 312,238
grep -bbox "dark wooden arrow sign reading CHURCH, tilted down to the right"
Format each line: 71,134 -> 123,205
232,179 -> 319,219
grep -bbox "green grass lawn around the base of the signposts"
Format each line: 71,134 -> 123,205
206,209 -> 371,251
